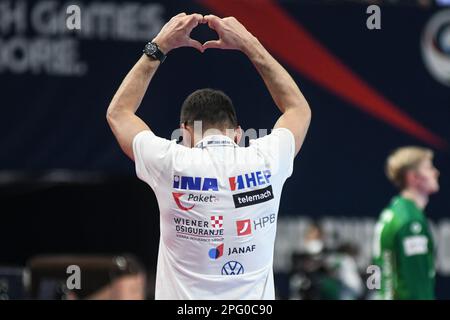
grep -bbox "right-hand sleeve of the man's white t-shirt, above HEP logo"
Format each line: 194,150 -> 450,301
250,128 -> 295,178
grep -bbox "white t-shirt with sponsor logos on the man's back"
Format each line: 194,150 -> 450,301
133,128 -> 295,300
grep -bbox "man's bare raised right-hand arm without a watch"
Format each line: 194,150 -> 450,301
203,15 -> 311,154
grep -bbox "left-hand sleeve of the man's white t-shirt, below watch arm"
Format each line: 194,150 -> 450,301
133,130 -> 177,188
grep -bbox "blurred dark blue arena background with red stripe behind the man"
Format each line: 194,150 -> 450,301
0,0 -> 450,299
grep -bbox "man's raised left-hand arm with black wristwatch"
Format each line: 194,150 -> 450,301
106,13 -> 203,159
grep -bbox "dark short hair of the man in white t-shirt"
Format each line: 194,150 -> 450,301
180,88 -> 238,130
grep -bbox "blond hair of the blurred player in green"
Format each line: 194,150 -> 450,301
385,146 -> 433,189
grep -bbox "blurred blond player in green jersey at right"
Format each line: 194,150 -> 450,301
374,147 -> 439,300
